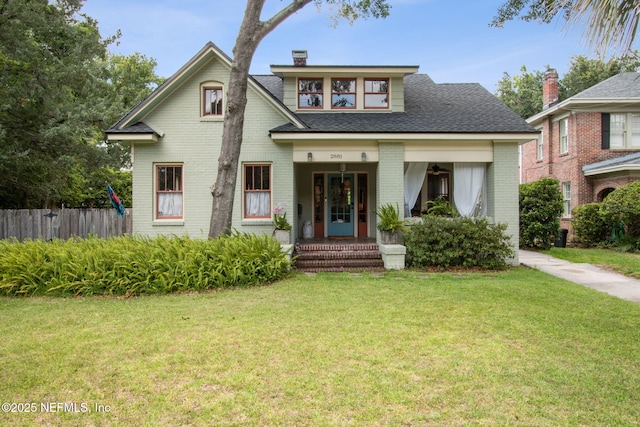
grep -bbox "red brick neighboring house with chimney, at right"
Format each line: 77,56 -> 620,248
520,69 -> 640,237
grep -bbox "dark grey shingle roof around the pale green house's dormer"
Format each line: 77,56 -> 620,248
256,74 -> 537,133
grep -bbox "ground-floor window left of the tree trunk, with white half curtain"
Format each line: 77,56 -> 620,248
156,165 -> 183,219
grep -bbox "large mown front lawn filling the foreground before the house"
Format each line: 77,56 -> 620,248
0,268 -> 640,426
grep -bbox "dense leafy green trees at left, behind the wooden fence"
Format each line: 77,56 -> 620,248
0,0 -> 158,208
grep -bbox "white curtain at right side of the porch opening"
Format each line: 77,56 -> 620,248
453,163 -> 487,217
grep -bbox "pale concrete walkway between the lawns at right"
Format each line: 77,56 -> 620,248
519,250 -> 640,303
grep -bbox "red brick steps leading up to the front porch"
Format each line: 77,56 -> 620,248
294,243 -> 384,272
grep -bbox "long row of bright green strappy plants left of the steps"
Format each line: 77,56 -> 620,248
0,234 -> 290,296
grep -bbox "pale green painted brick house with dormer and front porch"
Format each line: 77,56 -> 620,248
107,43 -> 536,263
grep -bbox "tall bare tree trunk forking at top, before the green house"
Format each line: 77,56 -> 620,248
209,0 -> 311,238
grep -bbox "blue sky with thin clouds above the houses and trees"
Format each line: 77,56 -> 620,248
77,0 -> 616,92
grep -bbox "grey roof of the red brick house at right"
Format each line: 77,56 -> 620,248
527,73 -> 640,125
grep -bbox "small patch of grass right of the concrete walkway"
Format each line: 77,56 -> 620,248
545,248 -> 640,279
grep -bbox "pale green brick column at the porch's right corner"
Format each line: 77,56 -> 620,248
487,142 -> 520,265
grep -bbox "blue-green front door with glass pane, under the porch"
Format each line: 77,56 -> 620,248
327,173 -> 354,237
